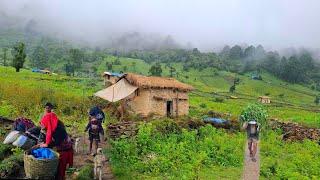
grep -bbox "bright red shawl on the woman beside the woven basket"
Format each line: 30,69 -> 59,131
40,112 -> 58,145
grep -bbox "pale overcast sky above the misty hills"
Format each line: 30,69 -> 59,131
0,0 -> 320,49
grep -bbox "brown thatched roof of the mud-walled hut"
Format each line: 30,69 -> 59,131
124,73 -> 193,91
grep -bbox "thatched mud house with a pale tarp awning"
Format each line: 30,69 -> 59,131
95,73 -> 193,117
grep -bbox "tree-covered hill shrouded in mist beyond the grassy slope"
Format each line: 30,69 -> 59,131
0,26 -> 320,89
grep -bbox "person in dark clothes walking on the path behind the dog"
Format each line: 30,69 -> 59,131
85,117 -> 104,155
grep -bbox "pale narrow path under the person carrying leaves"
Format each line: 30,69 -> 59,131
242,142 -> 260,180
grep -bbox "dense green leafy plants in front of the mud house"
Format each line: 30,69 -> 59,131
109,121 -> 244,179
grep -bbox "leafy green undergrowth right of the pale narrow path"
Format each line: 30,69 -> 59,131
260,131 -> 320,179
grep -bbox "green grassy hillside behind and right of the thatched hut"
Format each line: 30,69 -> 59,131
99,56 -> 320,127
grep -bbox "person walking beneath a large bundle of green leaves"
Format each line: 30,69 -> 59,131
243,120 -> 259,162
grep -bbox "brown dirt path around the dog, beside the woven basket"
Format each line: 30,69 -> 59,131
67,136 -> 115,180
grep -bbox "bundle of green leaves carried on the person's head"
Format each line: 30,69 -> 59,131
240,104 -> 268,126
